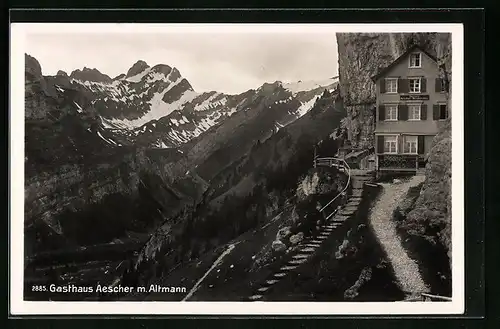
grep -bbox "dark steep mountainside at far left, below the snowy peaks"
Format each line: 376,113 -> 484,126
25,55 -> 205,255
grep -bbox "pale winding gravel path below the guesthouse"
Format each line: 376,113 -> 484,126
370,176 -> 429,297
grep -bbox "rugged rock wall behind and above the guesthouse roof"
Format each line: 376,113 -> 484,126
337,33 -> 451,148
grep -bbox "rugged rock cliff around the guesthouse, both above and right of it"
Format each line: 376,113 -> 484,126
337,33 -> 453,259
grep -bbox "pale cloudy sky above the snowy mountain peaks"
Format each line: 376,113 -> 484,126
25,30 -> 338,94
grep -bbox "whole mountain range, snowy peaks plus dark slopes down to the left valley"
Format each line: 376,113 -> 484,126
25,55 -> 338,254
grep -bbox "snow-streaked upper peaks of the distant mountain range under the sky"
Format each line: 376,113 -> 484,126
37,56 -> 338,148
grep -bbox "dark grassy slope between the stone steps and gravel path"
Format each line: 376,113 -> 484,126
266,184 -> 404,301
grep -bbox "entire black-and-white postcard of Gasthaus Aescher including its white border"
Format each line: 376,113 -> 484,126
10,23 -> 465,314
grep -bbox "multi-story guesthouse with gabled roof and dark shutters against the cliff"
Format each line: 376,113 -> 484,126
372,46 -> 448,172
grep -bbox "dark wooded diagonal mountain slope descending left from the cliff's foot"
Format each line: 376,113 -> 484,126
129,91 -> 345,290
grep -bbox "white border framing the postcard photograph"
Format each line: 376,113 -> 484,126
9,23 -> 465,315
